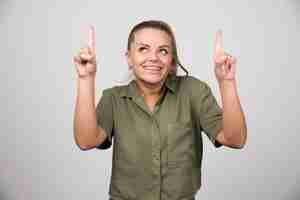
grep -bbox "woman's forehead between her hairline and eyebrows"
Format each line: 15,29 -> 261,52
134,28 -> 171,45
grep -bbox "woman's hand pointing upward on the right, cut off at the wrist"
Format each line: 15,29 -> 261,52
213,30 -> 236,82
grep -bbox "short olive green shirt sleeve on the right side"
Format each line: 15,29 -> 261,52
192,80 -> 223,147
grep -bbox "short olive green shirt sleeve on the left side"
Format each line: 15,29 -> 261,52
96,89 -> 114,149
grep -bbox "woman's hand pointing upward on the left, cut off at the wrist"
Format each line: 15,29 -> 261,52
73,26 -> 97,78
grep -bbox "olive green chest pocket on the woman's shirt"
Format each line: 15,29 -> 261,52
167,122 -> 195,166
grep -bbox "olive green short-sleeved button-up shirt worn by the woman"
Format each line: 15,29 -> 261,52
96,76 -> 222,200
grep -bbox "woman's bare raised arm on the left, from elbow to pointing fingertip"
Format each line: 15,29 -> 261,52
74,27 -> 107,150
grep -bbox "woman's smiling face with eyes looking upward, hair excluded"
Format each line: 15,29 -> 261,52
127,28 -> 173,85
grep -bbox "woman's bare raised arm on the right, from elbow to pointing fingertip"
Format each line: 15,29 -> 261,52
213,31 -> 247,148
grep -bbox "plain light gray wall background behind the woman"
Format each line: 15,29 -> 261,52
0,0 -> 300,200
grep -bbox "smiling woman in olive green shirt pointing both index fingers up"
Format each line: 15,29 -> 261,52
74,21 -> 247,200
